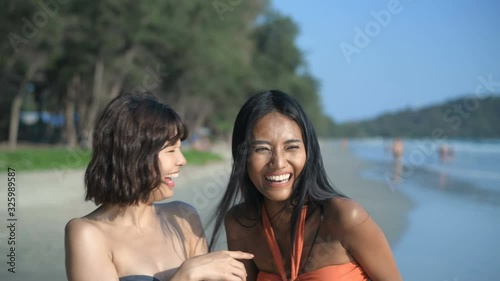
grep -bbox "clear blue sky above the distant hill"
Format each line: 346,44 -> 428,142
271,0 -> 500,122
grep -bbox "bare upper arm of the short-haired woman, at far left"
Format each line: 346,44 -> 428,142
64,219 -> 118,281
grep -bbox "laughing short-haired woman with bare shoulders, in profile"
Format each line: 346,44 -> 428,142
65,93 -> 252,281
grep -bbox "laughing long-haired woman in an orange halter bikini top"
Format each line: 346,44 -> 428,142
210,90 -> 402,281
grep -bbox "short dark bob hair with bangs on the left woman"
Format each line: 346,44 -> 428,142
85,93 -> 188,206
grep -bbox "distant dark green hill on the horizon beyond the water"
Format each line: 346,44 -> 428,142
336,95 -> 500,138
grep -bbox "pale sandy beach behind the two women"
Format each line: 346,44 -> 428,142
0,142 -> 412,281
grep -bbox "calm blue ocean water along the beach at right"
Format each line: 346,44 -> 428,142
348,139 -> 500,281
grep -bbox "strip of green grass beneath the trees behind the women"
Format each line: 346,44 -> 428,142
0,148 -> 222,171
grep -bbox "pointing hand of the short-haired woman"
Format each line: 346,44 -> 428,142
171,251 -> 253,281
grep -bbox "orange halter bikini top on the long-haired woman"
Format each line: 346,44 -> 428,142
257,205 -> 368,281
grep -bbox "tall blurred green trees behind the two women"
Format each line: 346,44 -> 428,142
0,0 -> 334,148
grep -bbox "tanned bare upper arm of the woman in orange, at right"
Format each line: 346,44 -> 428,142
340,200 -> 403,281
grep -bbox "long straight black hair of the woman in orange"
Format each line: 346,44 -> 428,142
209,90 -> 345,250
